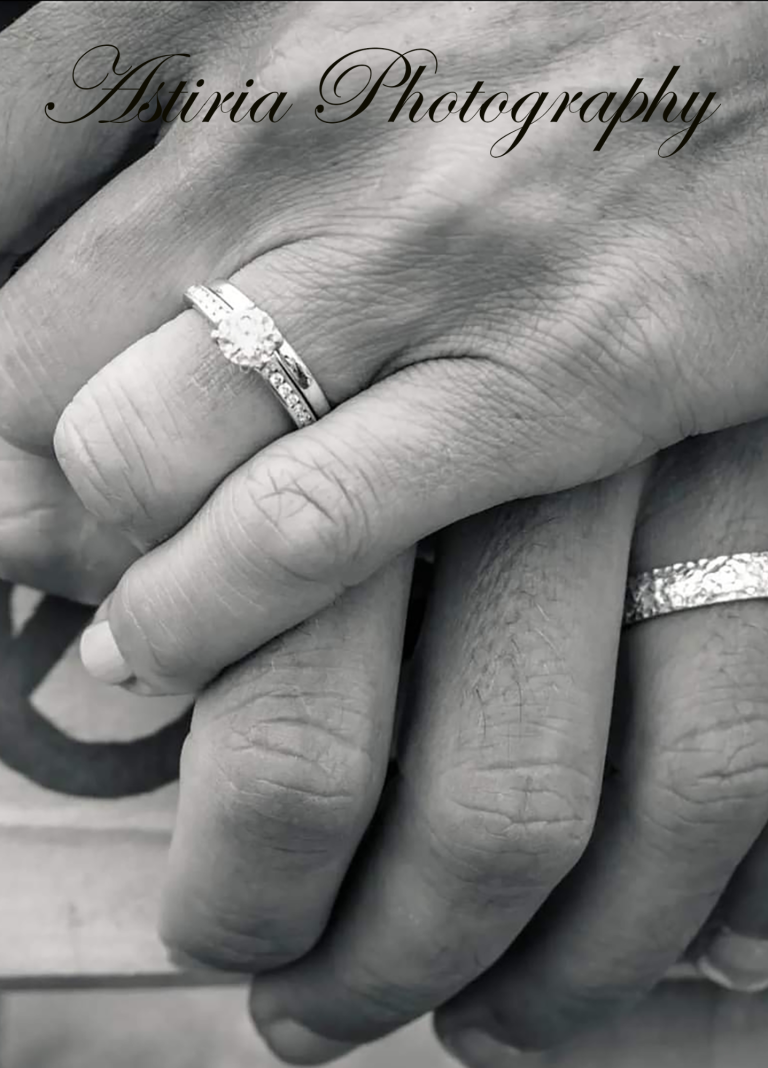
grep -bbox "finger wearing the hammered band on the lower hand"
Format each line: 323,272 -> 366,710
437,424 -> 768,1066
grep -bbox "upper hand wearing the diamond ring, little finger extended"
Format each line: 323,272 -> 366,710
0,3 -> 768,692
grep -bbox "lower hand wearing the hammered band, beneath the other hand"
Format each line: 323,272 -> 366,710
76,412 -> 768,1066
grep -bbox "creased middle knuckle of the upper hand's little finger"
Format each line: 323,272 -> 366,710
235,447 -> 371,583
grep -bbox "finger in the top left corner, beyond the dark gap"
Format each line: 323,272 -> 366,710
0,0 -> 186,254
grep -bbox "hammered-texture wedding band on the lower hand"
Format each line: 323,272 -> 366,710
624,552 -> 768,627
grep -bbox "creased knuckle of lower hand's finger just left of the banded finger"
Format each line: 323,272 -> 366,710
430,765 -> 596,893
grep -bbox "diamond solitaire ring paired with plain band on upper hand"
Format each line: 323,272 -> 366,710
184,282 -> 330,427
